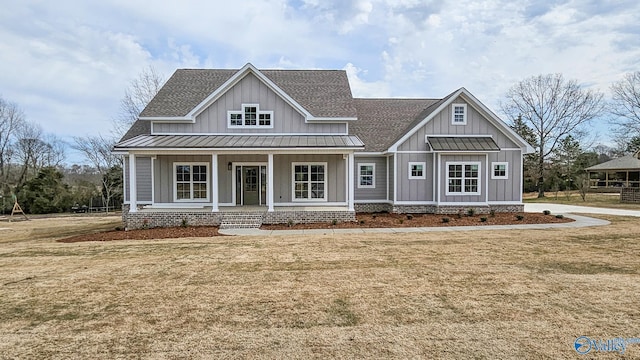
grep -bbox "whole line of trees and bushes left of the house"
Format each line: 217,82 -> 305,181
0,67 -> 164,214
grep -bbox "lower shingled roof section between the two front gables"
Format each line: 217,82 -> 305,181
349,99 -> 440,152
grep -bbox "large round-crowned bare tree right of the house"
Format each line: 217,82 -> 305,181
501,74 -> 603,197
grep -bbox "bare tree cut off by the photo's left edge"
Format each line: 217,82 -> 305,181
0,97 -> 25,183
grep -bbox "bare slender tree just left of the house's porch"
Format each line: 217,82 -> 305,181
71,135 -> 122,212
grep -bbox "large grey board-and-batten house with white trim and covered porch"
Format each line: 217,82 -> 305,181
114,64 -> 533,228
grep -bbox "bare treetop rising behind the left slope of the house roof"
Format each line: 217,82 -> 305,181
113,66 -> 164,138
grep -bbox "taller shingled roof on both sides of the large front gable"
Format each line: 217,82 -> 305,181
140,69 -> 356,118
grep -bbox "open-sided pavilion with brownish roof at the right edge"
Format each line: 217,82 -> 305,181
585,150 -> 640,189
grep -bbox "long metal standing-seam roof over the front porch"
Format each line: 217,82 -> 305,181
114,135 -> 364,151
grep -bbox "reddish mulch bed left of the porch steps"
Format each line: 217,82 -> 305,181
58,226 -> 221,243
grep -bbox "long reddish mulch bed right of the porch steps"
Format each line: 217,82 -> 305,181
261,213 -> 574,230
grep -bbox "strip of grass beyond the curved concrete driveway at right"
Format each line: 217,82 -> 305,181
523,191 -> 640,210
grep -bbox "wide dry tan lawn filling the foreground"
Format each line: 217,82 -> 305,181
0,217 -> 640,359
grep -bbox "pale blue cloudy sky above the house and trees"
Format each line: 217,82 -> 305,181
0,0 -> 640,162
